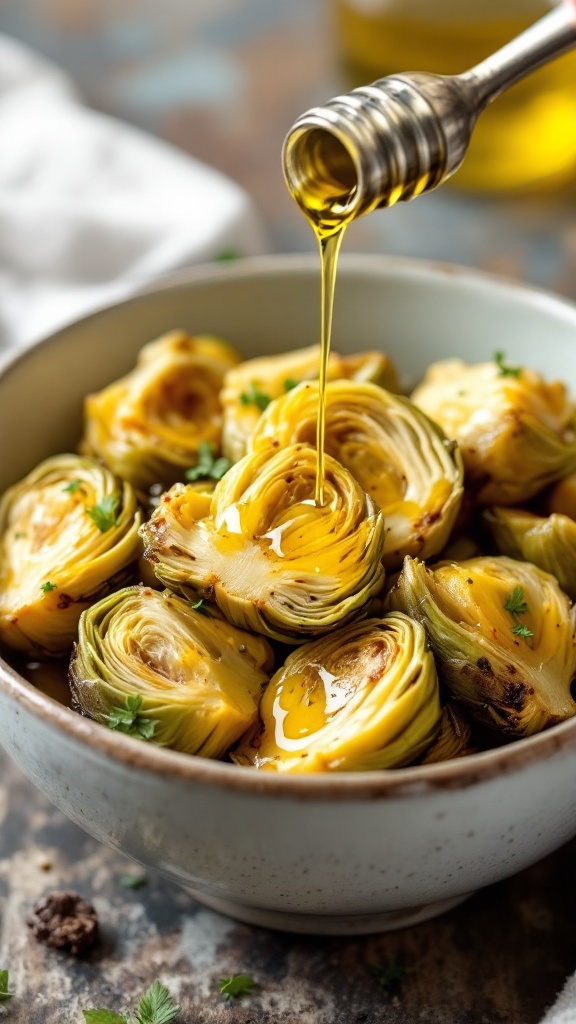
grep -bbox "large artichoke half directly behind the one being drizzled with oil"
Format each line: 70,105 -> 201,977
249,381 -> 463,569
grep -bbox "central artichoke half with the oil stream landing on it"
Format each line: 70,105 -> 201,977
141,444 -> 384,643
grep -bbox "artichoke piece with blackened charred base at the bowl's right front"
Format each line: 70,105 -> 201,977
387,555 -> 576,736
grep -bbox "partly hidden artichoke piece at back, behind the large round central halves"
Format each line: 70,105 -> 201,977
217,345 -> 399,462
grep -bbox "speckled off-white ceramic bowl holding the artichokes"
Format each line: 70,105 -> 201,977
0,255 -> 576,934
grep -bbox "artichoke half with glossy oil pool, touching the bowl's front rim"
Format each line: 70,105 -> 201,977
231,613 -> 441,772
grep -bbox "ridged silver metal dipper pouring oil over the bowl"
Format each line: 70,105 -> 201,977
283,0 -> 576,230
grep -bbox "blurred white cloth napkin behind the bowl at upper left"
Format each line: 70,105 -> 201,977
0,36 -> 266,348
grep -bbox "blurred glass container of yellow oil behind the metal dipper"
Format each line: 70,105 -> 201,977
334,0 -> 576,193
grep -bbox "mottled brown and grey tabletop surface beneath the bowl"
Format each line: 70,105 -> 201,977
0,0 -> 576,1024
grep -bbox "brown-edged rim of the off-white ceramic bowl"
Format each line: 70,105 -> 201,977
0,253 -> 576,802
